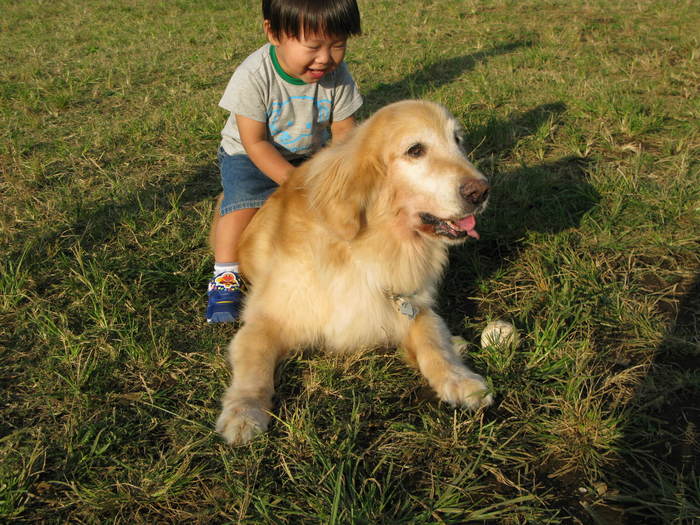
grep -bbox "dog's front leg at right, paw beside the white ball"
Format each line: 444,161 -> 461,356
403,310 -> 493,410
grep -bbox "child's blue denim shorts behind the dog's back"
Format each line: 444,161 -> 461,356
218,147 -> 277,215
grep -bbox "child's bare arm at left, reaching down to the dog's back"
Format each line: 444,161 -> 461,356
236,115 -> 296,184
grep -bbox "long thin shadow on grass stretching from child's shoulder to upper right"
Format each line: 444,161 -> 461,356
359,40 -> 533,119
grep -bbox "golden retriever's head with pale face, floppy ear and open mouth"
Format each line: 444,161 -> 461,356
306,100 -> 489,243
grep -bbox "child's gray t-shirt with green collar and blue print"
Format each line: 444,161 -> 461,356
219,44 -> 362,160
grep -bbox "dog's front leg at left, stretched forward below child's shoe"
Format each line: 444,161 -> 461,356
216,319 -> 284,445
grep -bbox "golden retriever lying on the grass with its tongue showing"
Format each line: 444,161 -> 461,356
216,100 -> 492,444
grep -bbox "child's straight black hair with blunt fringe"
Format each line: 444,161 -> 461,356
262,0 -> 362,39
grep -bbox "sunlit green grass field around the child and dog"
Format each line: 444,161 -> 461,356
0,0 -> 700,524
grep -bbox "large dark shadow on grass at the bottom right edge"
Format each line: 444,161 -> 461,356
608,273 -> 700,523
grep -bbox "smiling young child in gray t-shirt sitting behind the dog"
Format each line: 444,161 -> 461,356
207,0 -> 362,323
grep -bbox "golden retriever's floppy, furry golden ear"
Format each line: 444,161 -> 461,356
305,134 -> 381,241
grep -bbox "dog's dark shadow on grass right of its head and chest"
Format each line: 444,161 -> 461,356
438,102 -> 600,328
